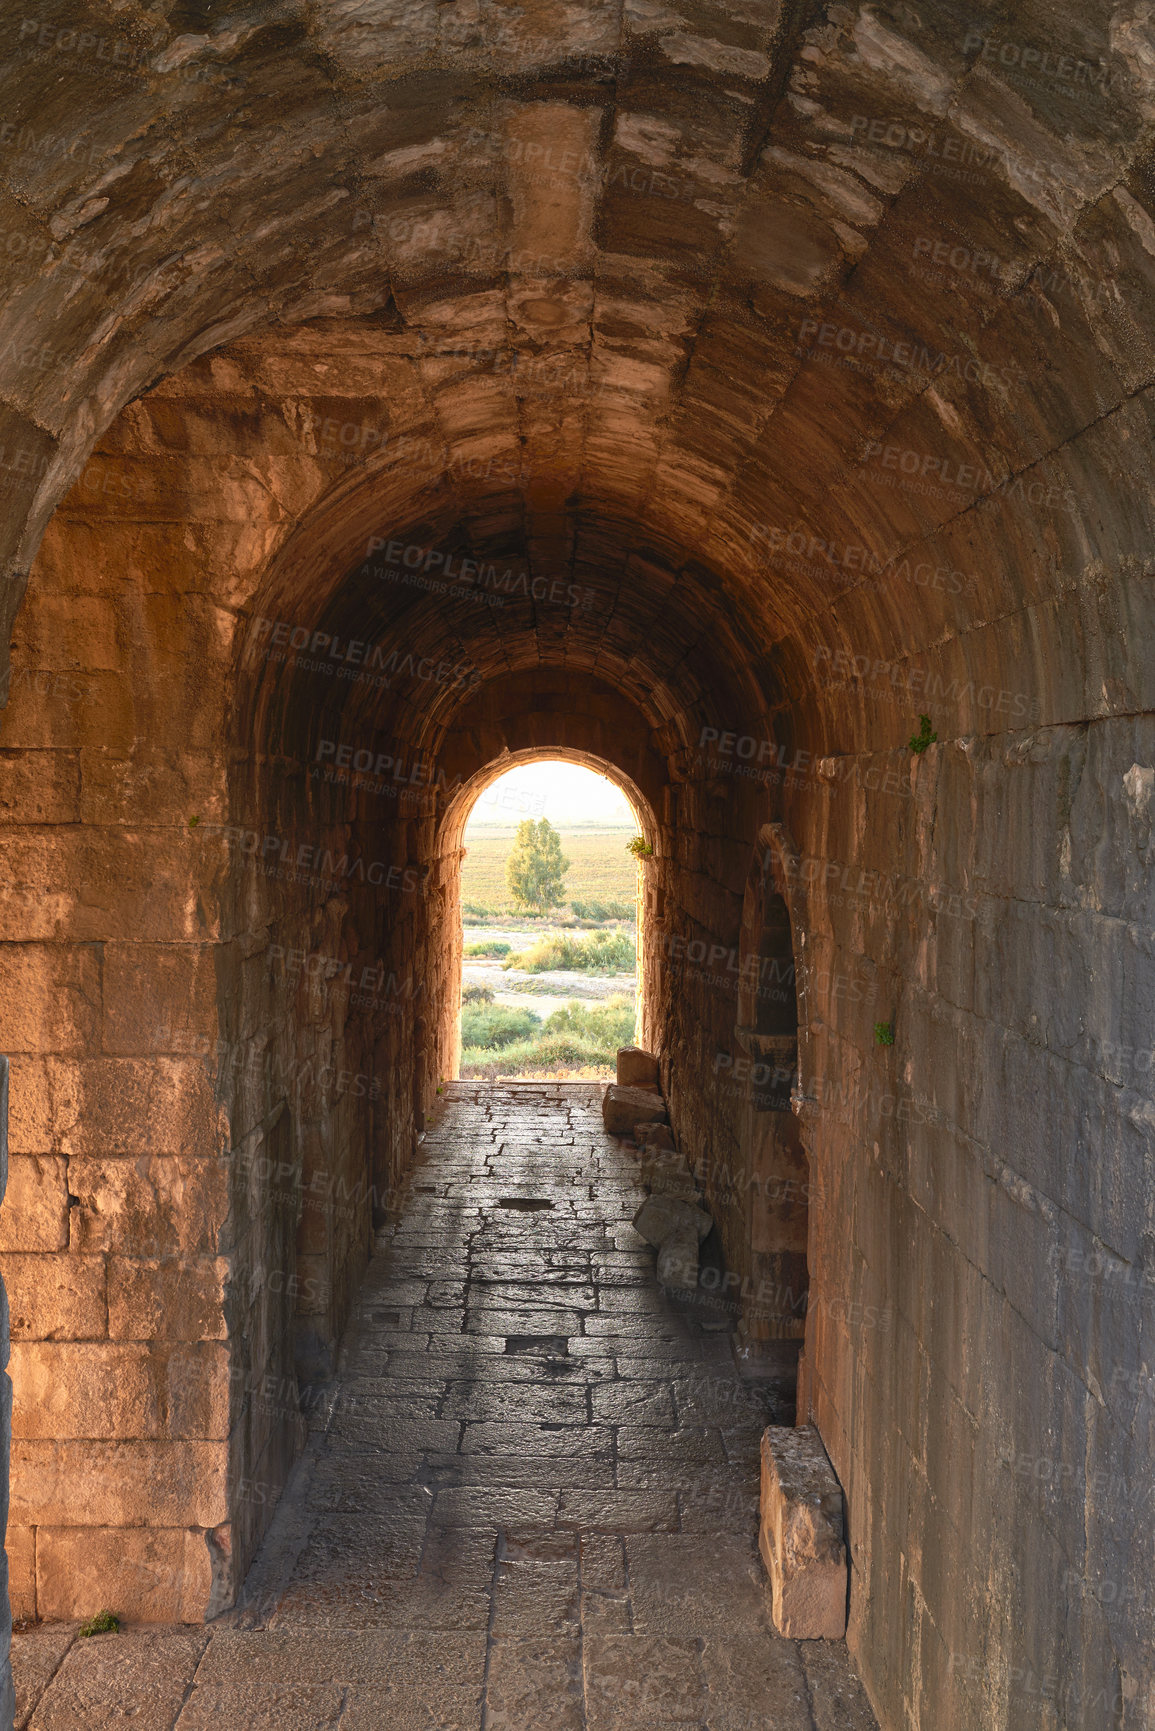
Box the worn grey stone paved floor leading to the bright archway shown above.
[14,1084,874,1731]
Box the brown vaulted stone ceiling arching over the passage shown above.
[9,0,1155,737]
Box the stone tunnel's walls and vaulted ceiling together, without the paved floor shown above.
[0,0,1155,1731]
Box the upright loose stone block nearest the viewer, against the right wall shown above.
[758,1425,849,1641]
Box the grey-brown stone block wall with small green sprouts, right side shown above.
[775,720,1155,1731]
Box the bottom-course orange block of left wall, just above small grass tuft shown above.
[36,1527,211,1622]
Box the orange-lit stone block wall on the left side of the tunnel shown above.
[0,409,447,1620]
